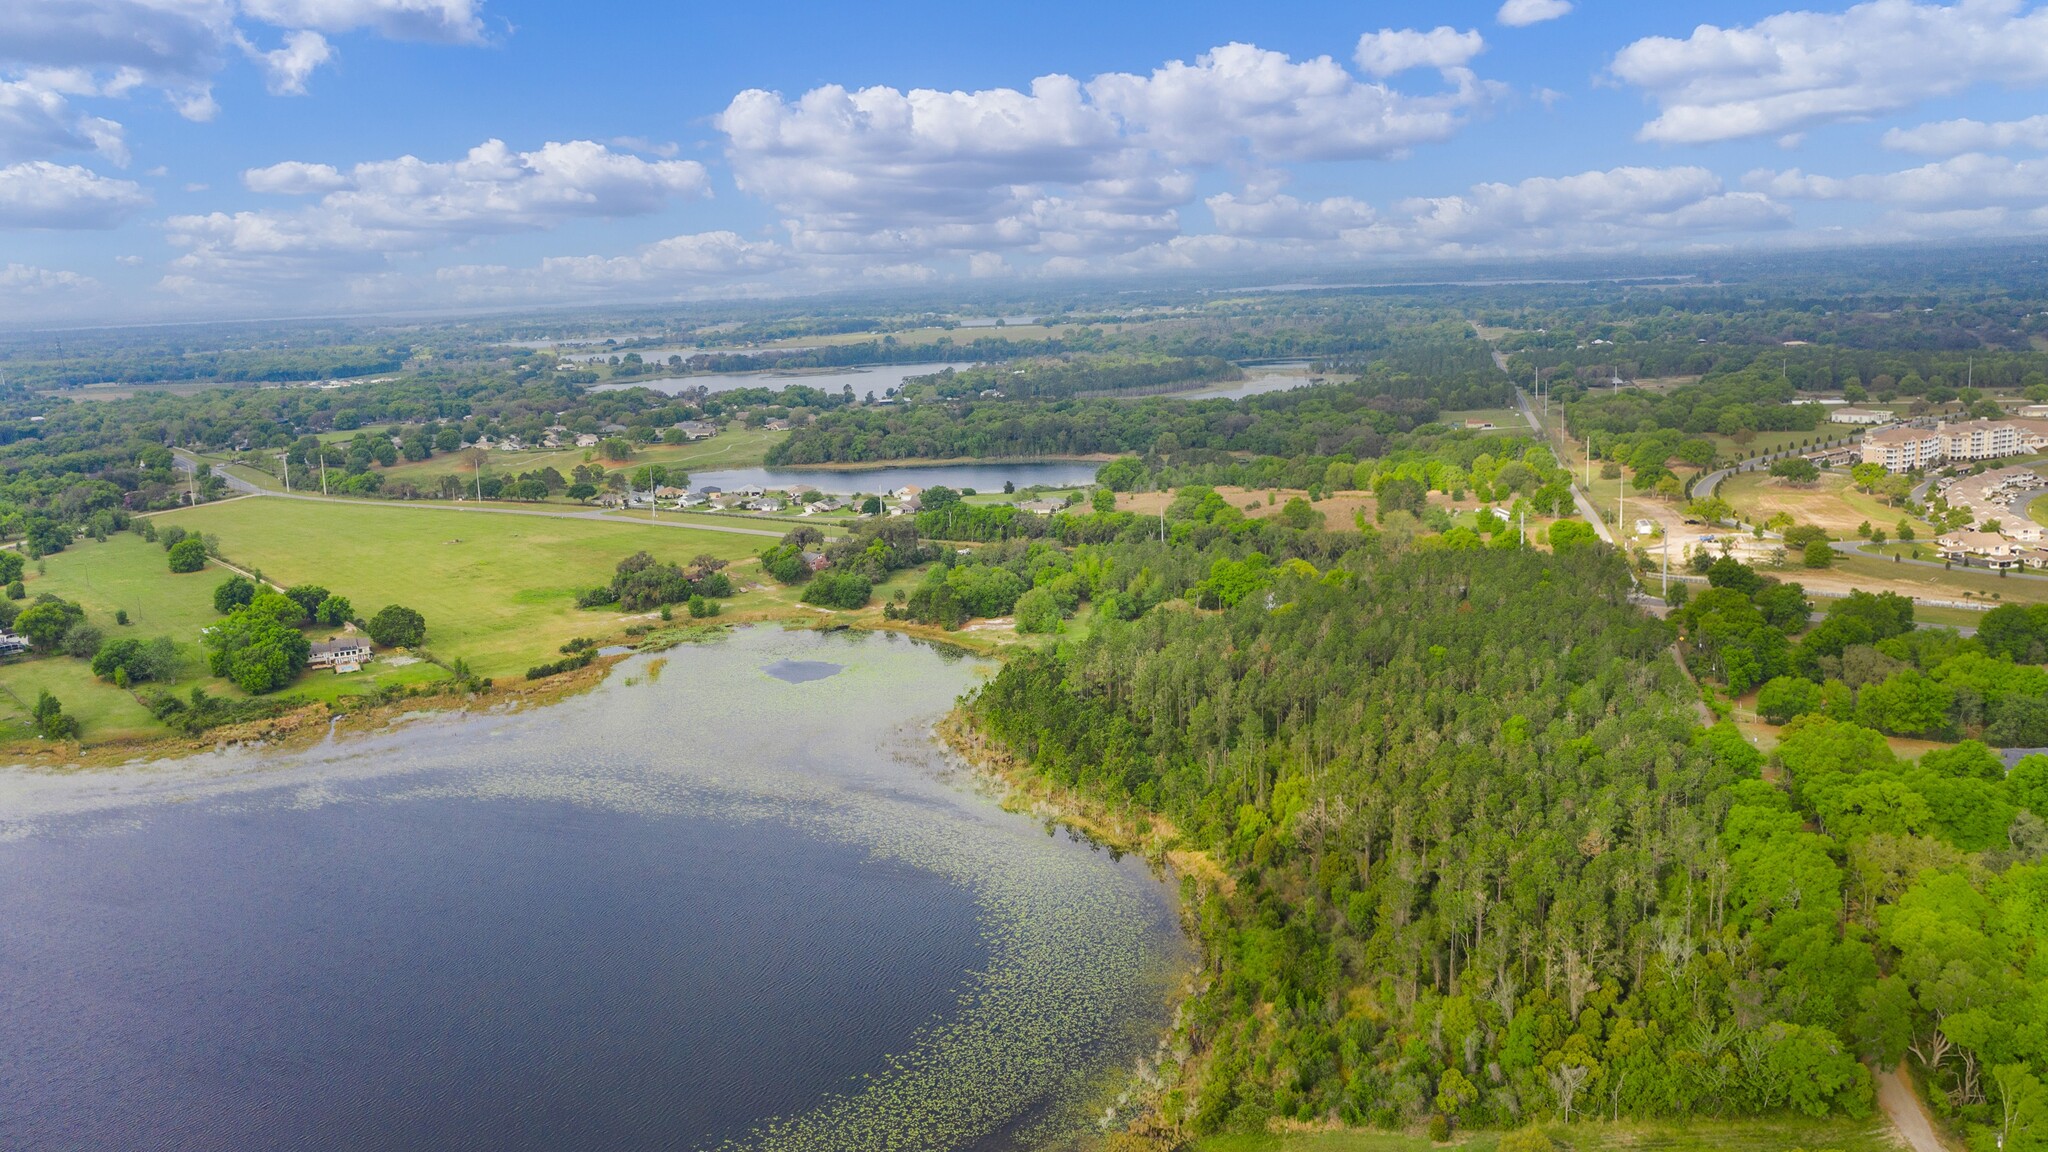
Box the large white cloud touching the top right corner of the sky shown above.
[1612,0,2048,143]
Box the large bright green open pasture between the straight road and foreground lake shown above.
[158,498,770,676]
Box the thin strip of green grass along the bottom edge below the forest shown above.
[1194,1117,1898,1152]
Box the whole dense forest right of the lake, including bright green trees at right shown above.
[967,537,2048,1146]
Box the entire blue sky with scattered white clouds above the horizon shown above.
[0,0,2048,322]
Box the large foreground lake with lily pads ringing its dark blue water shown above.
[0,629,1186,1152]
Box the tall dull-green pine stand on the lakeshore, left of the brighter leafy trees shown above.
[969,537,1908,1132]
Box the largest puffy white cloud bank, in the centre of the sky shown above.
[715,38,1499,256]
